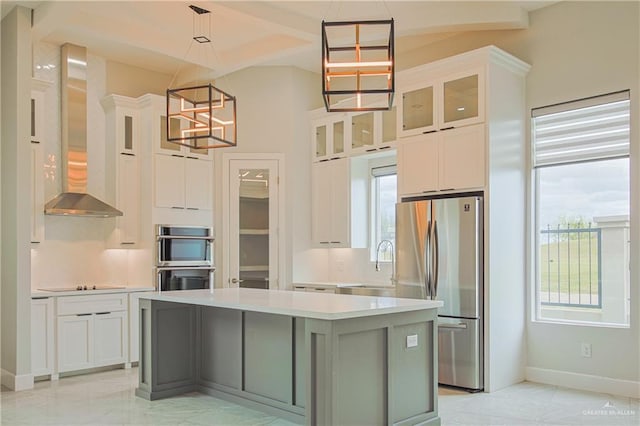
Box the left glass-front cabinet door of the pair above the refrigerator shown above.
[398,85,437,136]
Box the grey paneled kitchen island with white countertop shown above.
[136,289,442,425]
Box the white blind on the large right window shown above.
[531,90,630,167]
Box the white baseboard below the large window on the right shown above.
[525,367,640,398]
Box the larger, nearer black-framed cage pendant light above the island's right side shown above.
[322,19,395,112]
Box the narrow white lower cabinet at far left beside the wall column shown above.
[31,297,55,376]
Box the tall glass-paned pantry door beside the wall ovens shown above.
[228,160,278,289]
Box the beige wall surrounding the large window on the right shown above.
[527,2,640,397]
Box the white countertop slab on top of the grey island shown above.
[141,288,443,320]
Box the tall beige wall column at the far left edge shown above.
[0,7,33,390]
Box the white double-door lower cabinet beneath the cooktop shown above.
[56,293,129,373]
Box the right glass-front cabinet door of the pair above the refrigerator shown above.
[439,70,484,129]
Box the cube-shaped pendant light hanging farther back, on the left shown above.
[167,5,237,149]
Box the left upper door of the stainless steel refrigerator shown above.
[396,200,431,299]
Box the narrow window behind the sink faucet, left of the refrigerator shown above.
[370,165,397,262]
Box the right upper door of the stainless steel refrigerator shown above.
[431,197,482,318]
